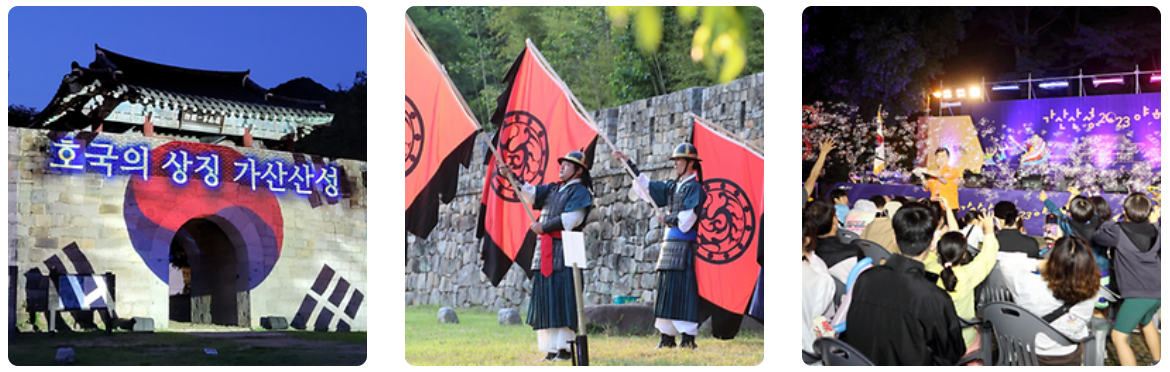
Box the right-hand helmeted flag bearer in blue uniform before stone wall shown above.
[614,143,704,349]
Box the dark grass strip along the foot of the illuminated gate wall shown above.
[8,331,366,366]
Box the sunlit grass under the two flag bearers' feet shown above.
[406,306,764,366]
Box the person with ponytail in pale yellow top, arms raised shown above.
[923,218,999,365]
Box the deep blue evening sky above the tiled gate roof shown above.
[8,7,367,110]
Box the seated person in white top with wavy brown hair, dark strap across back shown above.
[999,235,1100,365]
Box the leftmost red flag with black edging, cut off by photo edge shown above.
[405,16,480,239]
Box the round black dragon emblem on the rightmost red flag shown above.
[696,178,756,264]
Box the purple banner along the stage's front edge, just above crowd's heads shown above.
[833,184,1126,236]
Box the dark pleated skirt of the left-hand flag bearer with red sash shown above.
[528,268,577,331]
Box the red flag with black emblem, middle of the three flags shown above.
[476,41,597,285]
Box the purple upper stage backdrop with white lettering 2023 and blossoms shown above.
[971,92,1162,170]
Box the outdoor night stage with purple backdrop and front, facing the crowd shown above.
[823,87,1162,235]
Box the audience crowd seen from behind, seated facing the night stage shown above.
[801,142,1161,365]
